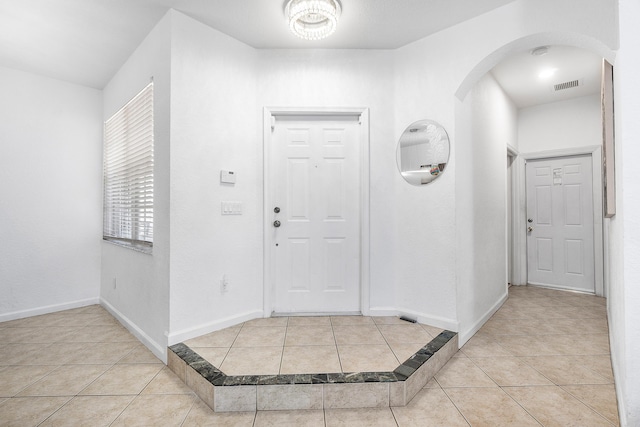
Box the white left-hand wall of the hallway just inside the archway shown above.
[456,74,518,342]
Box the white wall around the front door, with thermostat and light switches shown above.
[169,13,399,342]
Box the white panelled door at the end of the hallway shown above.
[526,156,595,292]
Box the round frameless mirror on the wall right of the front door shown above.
[396,120,449,185]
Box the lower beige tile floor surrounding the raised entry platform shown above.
[0,287,618,427]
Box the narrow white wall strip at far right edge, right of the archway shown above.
[607,0,640,426]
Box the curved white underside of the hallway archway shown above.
[455,32,616,101]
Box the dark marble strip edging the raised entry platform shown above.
[169,331,456,386]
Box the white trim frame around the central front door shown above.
[262,107,370,317]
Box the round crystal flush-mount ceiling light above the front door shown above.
[284,0,342,40]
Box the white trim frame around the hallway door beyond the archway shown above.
[514,145,606,296]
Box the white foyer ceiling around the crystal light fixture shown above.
[0,0,513,89]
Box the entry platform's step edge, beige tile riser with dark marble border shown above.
[168,331,458,411]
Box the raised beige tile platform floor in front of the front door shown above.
[180,316,442,375]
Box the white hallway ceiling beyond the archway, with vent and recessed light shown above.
[491,46,602,108]
